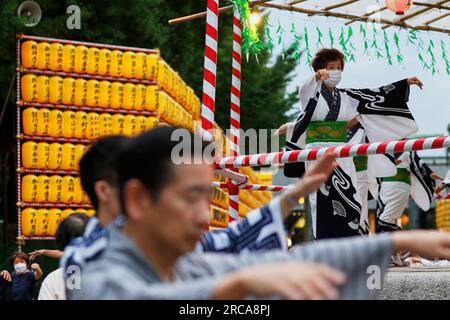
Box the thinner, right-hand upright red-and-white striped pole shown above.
[228,8,241,222]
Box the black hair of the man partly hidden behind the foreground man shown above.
[80,136,129,209]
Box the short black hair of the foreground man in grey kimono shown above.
[118,126,214,215]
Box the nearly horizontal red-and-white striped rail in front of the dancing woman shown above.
[216,136,450,168]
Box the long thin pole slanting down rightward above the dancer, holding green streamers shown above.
[258,3,450,35]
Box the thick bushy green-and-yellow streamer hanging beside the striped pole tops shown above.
[231,0,264,60]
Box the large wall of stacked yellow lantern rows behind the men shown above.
[18,40,206,237]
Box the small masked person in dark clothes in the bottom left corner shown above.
[0,252,42,300]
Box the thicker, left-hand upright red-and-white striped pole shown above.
[201,0,219,141]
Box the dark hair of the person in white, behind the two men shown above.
[55,213,89,251]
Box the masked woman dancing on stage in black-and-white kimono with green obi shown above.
[278,48,423,239]
